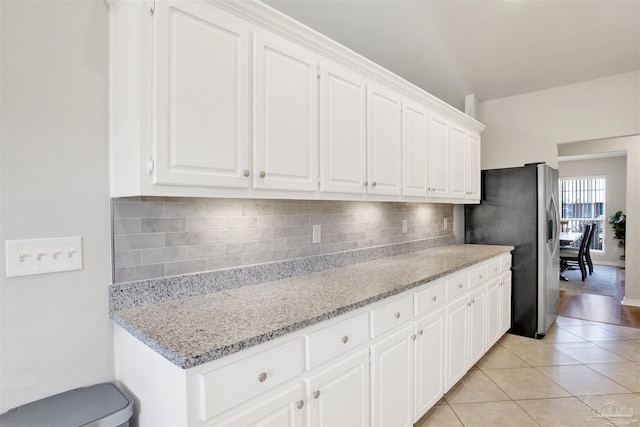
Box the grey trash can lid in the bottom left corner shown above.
[0,383,133,427]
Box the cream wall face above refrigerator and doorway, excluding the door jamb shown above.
[477,71,640,169]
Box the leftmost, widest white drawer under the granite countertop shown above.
[198,339,303,421]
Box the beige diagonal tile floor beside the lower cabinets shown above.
[414,317,640,427]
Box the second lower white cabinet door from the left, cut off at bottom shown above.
[307,347,369,427]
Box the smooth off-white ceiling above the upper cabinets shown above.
[263,0,640,110]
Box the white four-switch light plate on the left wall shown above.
[5,236,82,277]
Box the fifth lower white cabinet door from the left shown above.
[444,295,469,393]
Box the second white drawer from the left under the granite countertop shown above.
[306,312,369,369]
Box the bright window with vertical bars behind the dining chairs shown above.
[560,177,606,251]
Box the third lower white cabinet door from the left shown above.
[371,323,414,427]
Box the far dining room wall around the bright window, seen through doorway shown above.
[558,156,627,265]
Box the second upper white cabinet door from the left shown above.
[253,33,318,191]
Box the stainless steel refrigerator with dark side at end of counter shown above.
[465,163,560,338]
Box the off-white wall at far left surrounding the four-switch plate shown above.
[0,0,114,412]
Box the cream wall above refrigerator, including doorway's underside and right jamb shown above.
[479,71,640,305]
